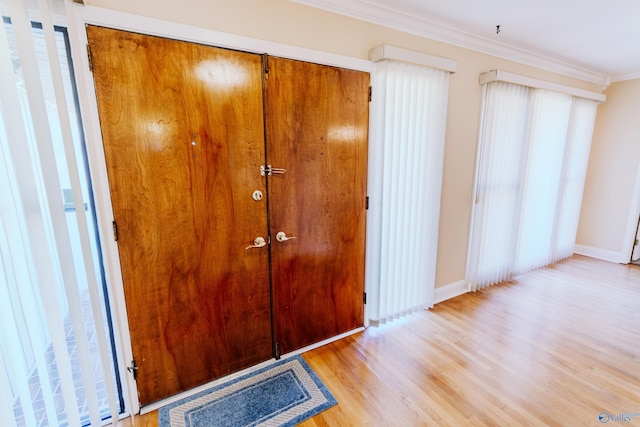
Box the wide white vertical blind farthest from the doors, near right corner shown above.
[467,81,597,290]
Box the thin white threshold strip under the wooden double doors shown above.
[139,327,365,415]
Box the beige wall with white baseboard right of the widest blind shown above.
[576,79,640,263]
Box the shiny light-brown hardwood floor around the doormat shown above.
[112,256,640,427]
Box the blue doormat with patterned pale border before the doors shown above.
[158,356,338,427]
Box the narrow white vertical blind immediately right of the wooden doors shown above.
[367,60,450,321]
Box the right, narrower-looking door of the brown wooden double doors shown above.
[265,57,369,353]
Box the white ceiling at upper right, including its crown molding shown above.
[292,0,640,87]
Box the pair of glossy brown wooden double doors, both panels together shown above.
[87,26,369,405]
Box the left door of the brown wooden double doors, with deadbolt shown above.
[87,26,272,405]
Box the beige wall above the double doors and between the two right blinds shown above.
[82,0,595,287]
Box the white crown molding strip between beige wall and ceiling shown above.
[289,0,608,85]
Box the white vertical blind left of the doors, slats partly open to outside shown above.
[0,0,122,426]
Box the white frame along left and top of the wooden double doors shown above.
[65,2,374,414]
